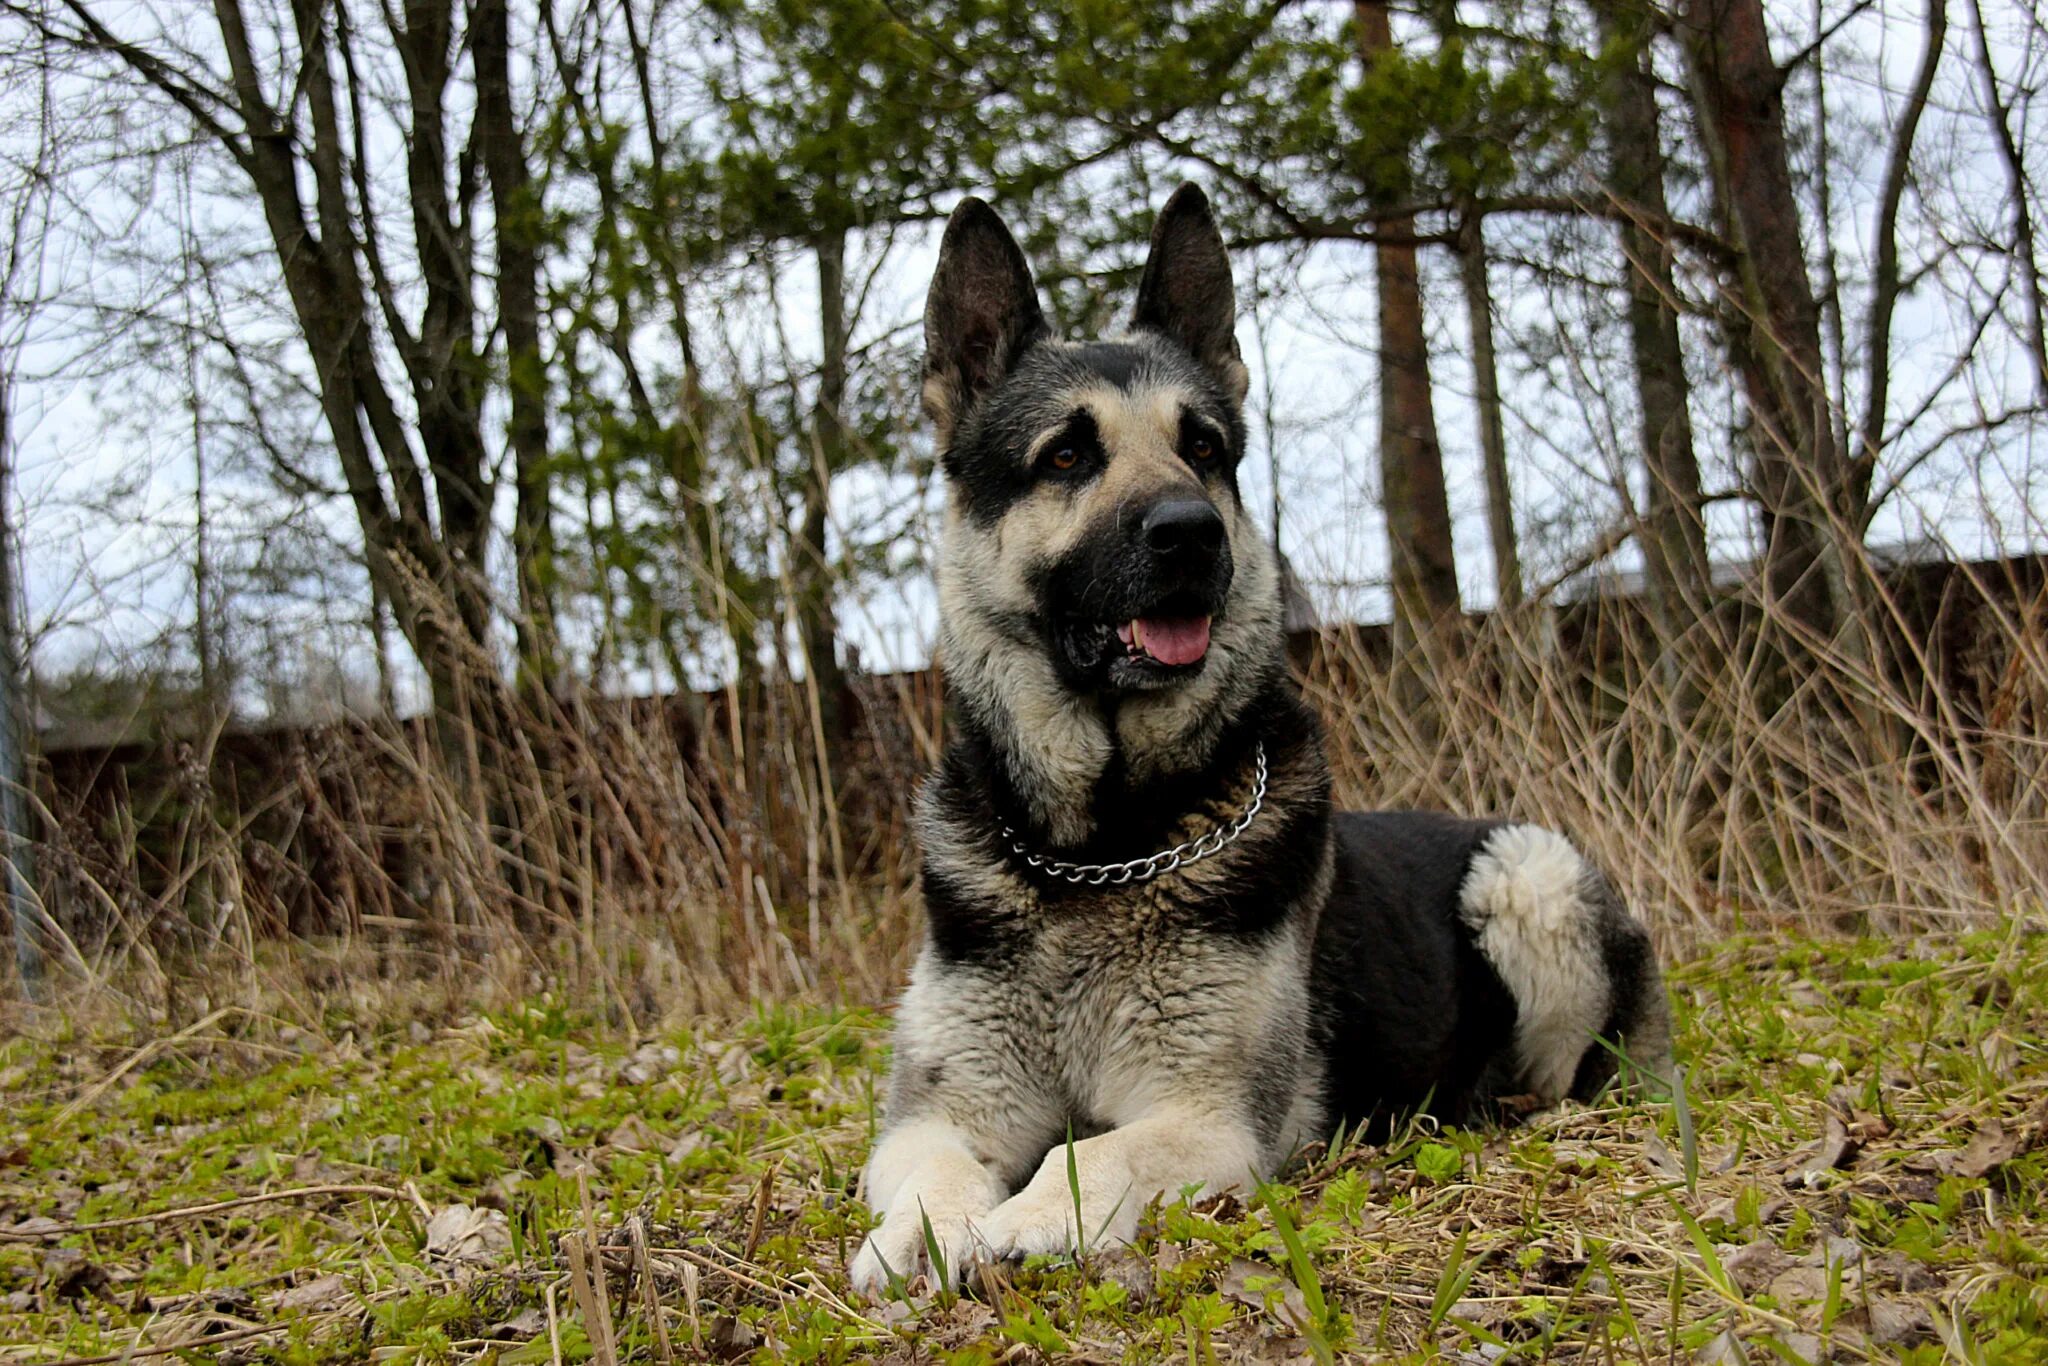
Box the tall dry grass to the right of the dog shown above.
[1307,544,2048,942]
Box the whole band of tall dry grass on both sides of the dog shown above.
[4,544,2048,1024]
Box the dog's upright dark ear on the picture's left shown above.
[924,199,1047,446]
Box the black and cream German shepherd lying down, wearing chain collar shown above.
[852,184,1669,1294]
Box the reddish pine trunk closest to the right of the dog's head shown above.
[1354,0,1460,657]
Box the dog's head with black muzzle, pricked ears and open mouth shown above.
[924,184,1278,739]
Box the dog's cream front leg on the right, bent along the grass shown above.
[979,1108,1264,1257]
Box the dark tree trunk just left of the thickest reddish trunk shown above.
[1595,0,1712,641]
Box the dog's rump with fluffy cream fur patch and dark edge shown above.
[1458,825,1671,1104]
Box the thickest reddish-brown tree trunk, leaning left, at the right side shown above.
[1679,0,1862,641]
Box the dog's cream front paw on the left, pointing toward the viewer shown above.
[850,1118,1004,1298]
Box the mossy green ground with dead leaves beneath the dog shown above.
[0,926,2048,1364]
